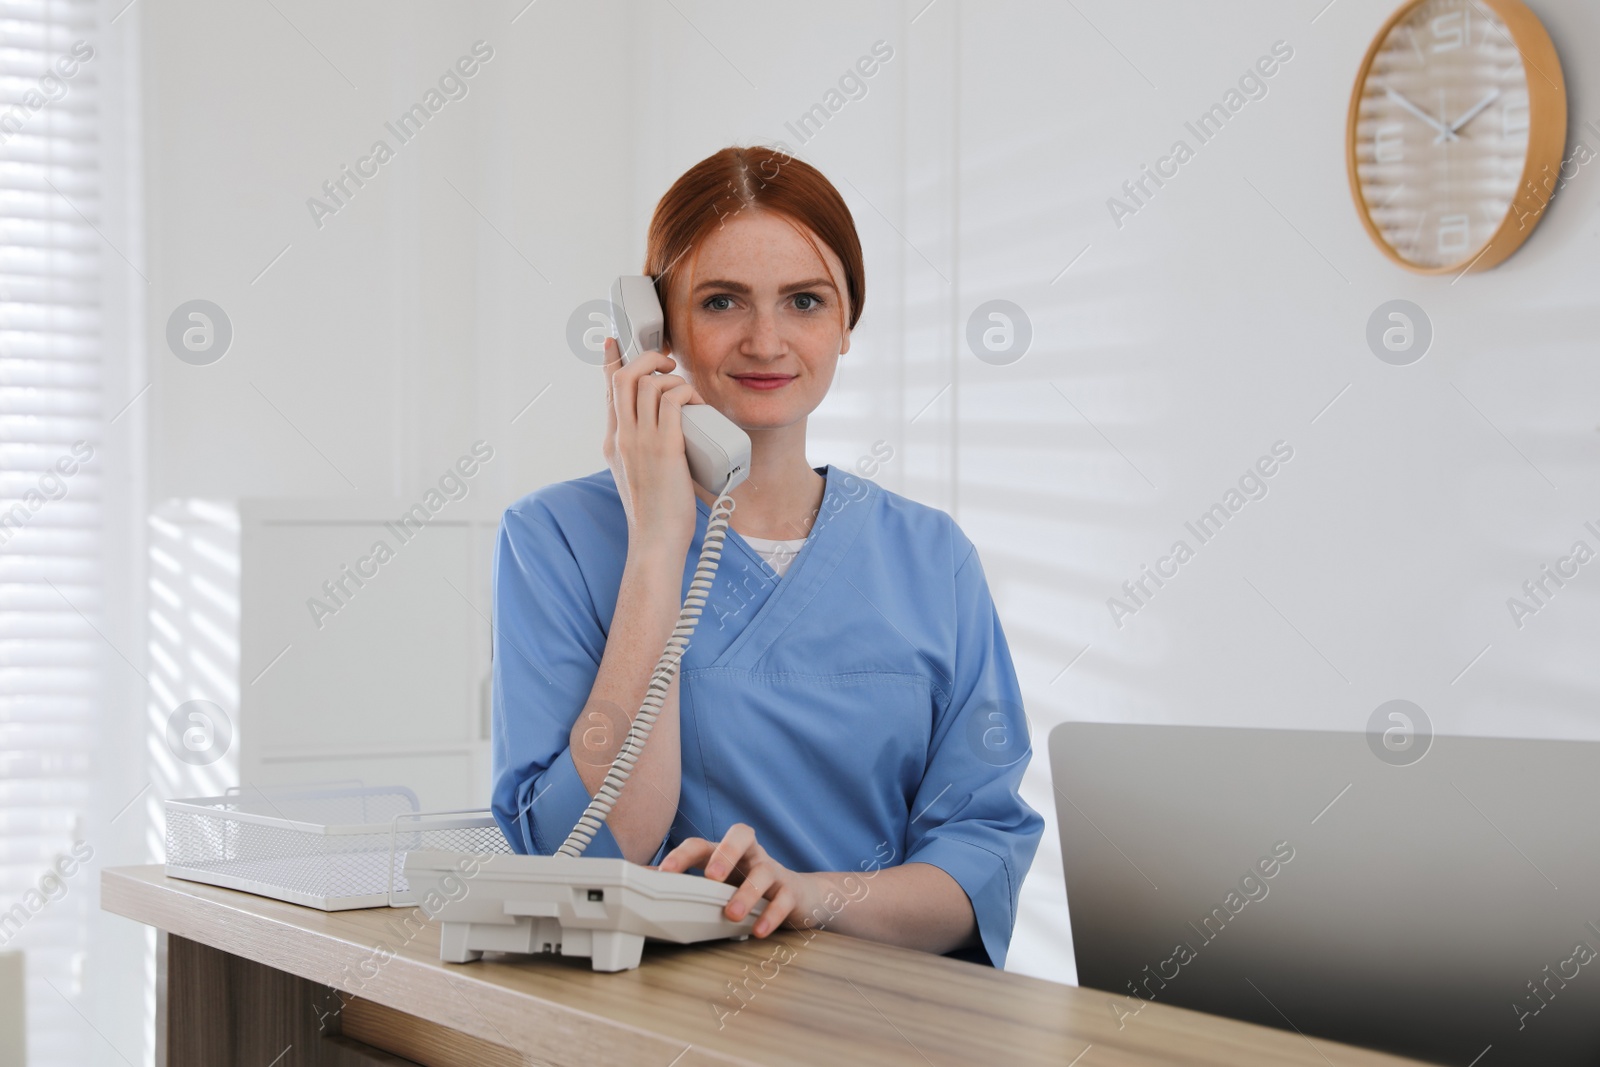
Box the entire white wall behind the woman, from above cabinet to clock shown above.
[128,0,1600,1017]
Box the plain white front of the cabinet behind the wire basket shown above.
[238,499,499,809]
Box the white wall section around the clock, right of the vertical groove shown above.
[934,0,1600,976]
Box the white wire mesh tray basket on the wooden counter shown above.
[166,785,512,912]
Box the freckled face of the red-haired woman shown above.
[669,210,850,430]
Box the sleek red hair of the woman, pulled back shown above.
[645,146,867,351]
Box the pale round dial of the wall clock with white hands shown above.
[1350,0,1529,269]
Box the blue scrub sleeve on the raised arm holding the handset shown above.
[491,502,659,861]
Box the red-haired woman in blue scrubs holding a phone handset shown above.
[493,147,1043,966]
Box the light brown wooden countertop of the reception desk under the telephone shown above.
[101,865,1440,1067]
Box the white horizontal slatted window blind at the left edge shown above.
[0,0,101,1067]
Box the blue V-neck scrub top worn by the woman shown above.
[493,466,1045,966]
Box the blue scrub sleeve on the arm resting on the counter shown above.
[906,550,1045,968]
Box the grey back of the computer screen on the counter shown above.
[1050,720,1600,1067]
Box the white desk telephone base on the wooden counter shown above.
[405,851,766,971]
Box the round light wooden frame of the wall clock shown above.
[1344,0,1566,274]
